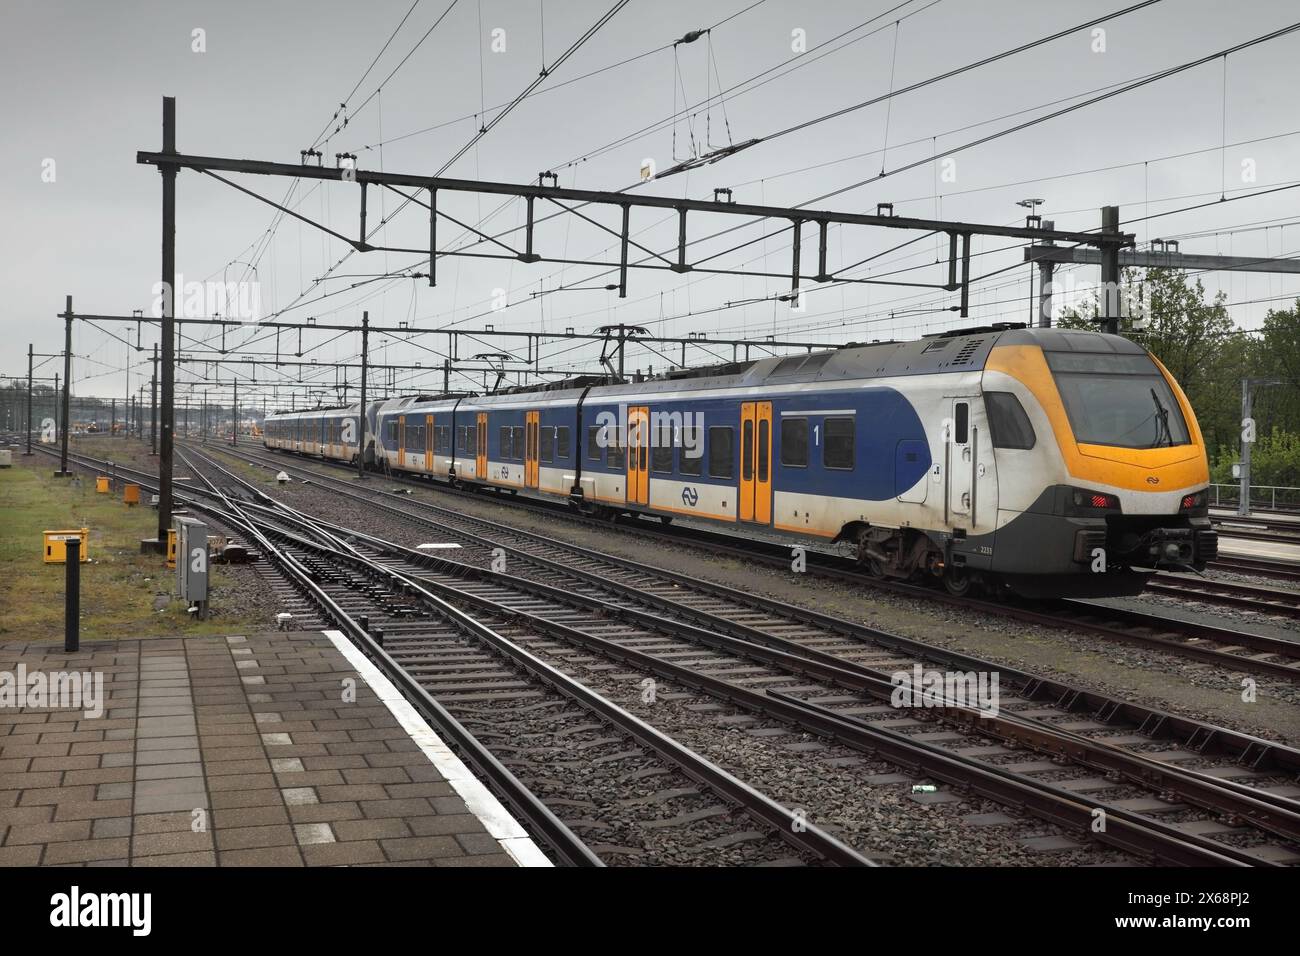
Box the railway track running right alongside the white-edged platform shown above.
[45,450,872,865]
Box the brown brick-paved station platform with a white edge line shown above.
[0,631,549,866]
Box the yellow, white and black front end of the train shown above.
[983,329,1218,597]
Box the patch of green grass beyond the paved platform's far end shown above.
[0,455,255,640]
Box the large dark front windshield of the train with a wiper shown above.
[1045,352,1191,449]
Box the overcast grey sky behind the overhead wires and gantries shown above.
[0,0,1300,405]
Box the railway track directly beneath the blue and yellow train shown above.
[213,450,1300,680]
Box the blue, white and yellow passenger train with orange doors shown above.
[264,324,1218,598]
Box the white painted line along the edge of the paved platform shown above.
[321,631,555,866]
